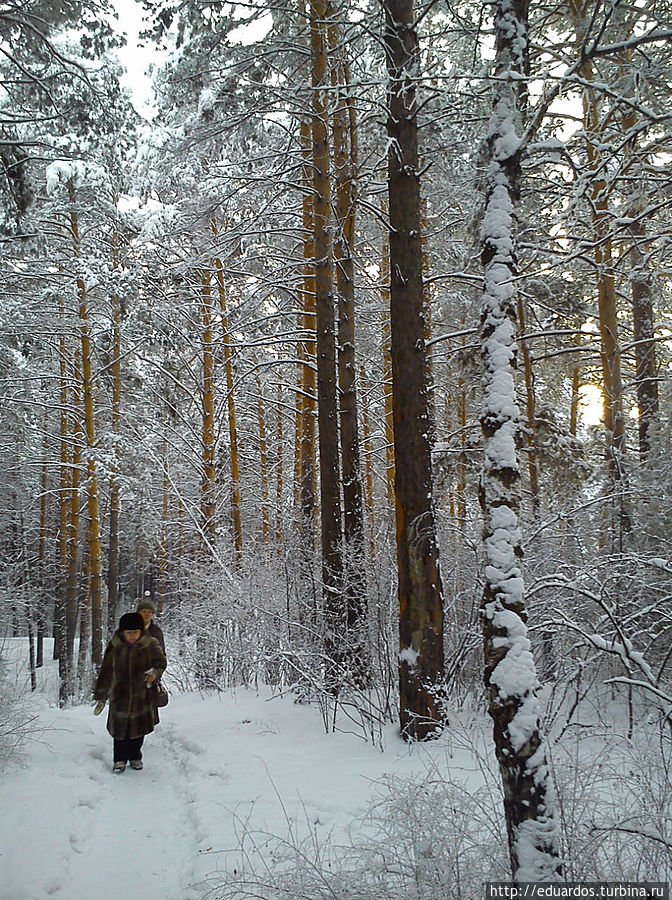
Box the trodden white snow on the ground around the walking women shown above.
[0,640,488,900]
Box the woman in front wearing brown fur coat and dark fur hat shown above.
[93,613,166,772]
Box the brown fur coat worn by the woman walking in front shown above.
[93,631,166,740]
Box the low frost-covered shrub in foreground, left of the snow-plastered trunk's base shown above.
[206,772,508,900]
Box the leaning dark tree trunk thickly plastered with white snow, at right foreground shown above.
[480,0,560,881]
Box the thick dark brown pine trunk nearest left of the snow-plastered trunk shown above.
[384,0,444,740]
